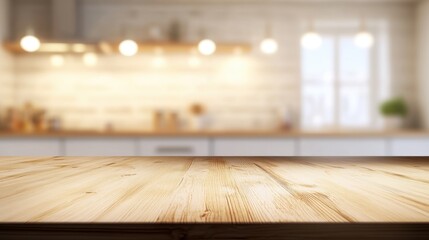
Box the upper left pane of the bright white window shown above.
[301,37,335,82]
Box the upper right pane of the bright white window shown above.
[339,36,370,82]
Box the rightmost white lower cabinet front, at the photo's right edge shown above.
[390,137,429,156]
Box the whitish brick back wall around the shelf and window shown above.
[10,0,416,129]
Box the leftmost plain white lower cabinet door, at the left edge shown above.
[0,138,62,156]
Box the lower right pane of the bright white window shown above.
[339,85,371,127]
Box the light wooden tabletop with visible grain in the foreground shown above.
[0,157,429,223]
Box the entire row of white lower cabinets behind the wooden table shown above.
[0,137,429,156]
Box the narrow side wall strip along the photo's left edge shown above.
[0,0,14,108]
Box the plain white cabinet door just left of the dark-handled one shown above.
[64,138,137,156]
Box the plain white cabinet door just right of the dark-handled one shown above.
[213,138,296,156]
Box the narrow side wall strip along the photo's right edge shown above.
[417,0,429,129]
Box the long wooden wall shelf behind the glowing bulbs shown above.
[3,42,252,54]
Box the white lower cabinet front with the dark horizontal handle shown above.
[138,137,210,156]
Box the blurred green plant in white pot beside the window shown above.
[380,97,408,130]
